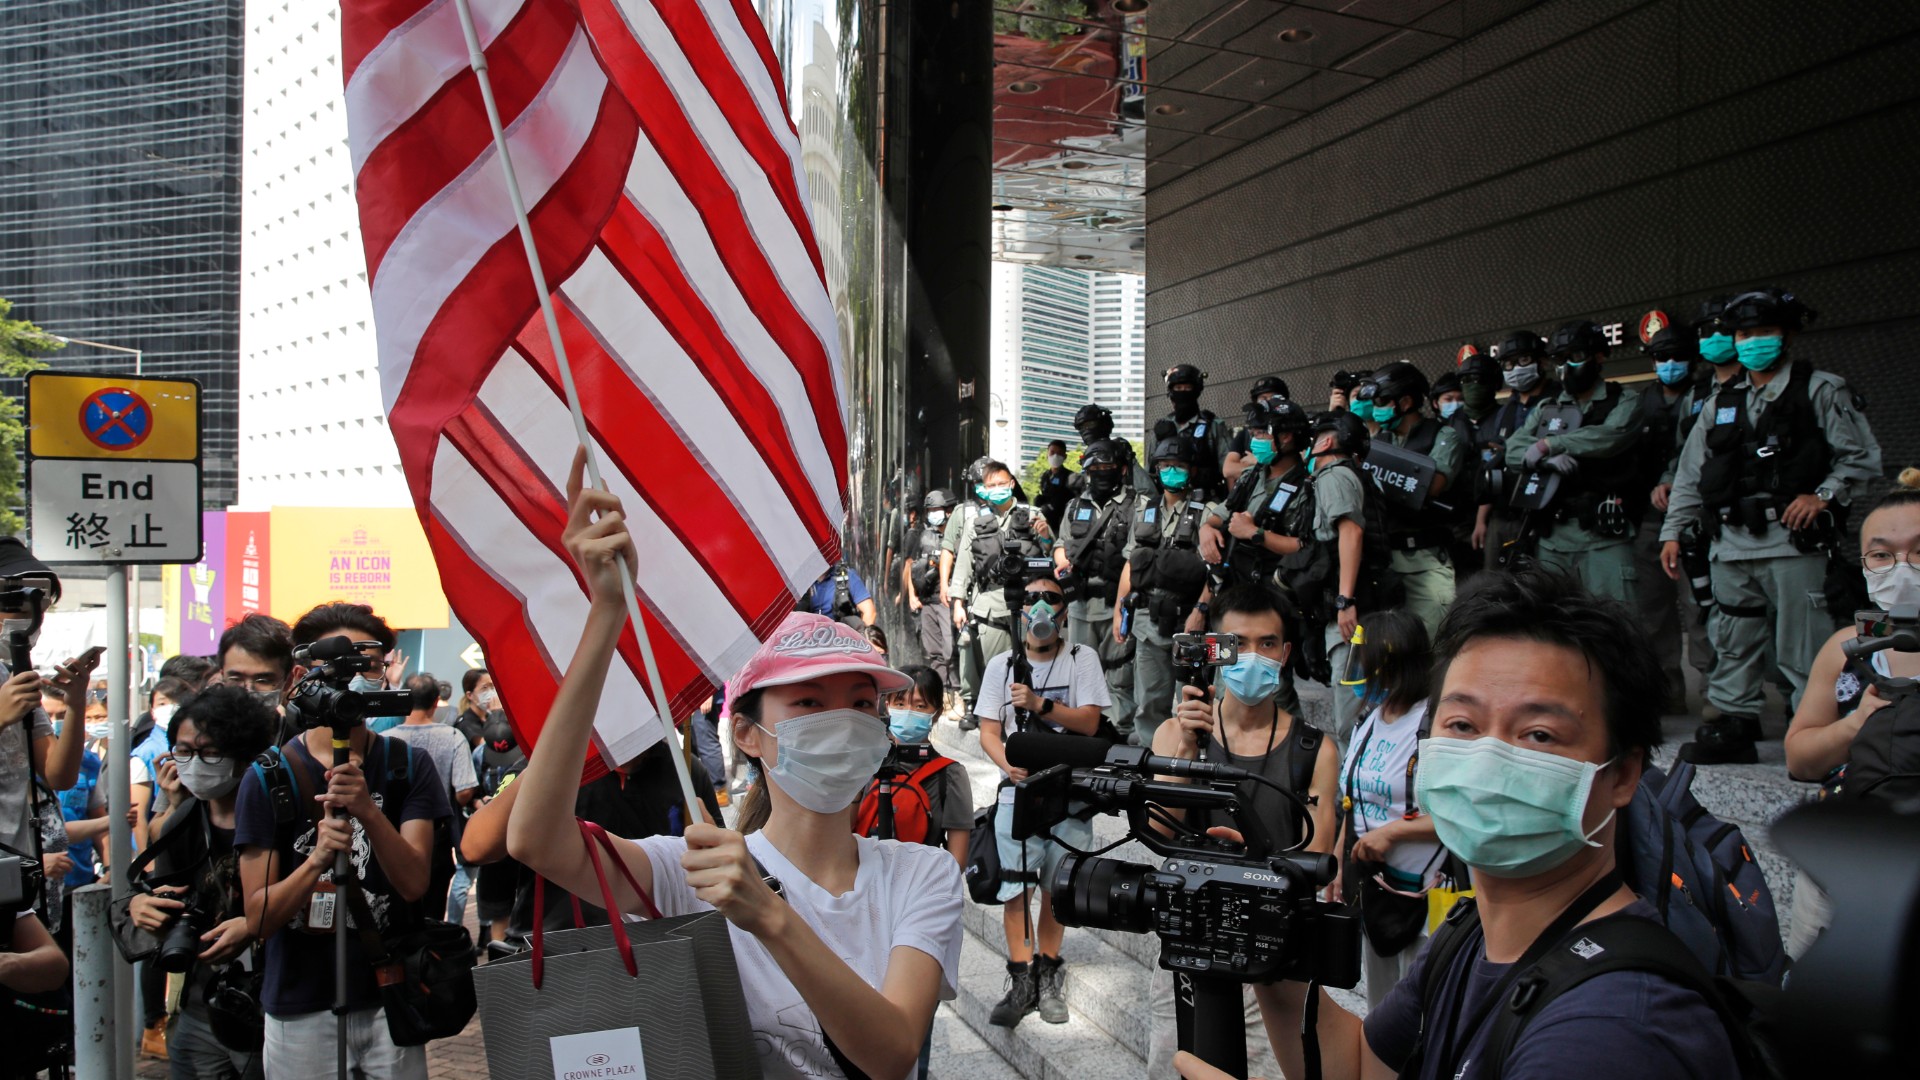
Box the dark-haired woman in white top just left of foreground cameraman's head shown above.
[1331,611,1446,1009]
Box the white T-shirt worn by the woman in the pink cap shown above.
[636,832,962,1080]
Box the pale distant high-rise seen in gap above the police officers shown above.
[989,263,1146,471]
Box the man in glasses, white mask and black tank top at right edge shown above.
[1786,469,1920,957]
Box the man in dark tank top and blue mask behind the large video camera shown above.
[1146,584,1340,1078]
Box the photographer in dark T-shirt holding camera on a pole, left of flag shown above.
[236,603,451,1080]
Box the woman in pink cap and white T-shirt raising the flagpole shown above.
[507,447,962,1080]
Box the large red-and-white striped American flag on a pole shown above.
[342,0,847,774]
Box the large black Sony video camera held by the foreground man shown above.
[1006,732,1359,988]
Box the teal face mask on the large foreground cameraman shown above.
[1413,738,1613,878]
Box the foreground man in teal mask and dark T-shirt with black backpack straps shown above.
[1179,571,1738,1080]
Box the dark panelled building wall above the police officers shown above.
[1146,0,1920,471]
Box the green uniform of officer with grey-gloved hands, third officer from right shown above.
[1507,382,1644,603]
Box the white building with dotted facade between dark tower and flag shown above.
[240,0,409,507]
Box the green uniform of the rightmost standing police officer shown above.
[1661,357,1880,717]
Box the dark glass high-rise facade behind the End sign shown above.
[0,0,242,507]
